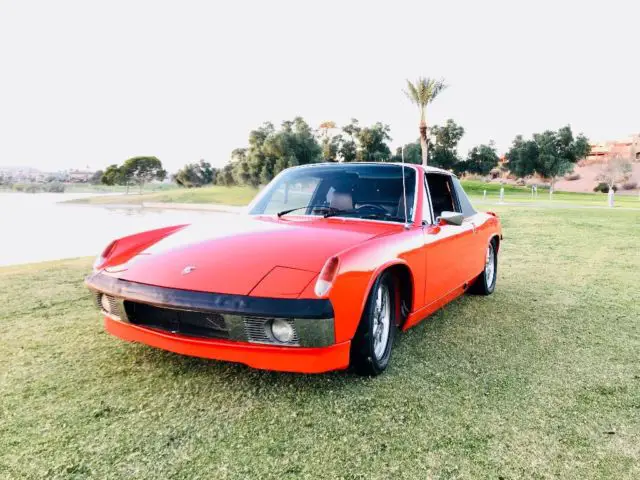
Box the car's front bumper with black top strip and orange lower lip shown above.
[85,272,350,373]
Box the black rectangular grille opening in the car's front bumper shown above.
[124,300,229,338]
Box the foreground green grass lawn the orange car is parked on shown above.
[0,206,640,479]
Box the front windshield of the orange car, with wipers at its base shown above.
[249,163,416,222]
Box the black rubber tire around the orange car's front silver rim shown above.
[351,272,398,377]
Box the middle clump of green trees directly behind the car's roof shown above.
[173,117,520,187]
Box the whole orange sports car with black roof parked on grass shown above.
[86,163,502,375]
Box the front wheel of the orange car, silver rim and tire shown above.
[351,273,397,376]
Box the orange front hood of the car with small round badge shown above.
[112,215,402,296]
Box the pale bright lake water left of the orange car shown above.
[0,193,234,265]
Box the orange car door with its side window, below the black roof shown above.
[423,172,475,305]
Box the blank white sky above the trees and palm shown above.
[0,0,640,171]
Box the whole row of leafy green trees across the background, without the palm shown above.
[87,117,589,190]
